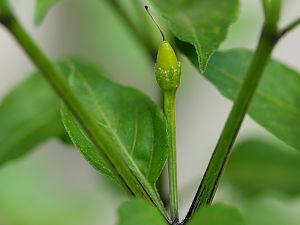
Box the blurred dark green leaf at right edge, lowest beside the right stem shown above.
[224,139,300,195]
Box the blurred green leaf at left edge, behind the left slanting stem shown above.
[0,74,65,164]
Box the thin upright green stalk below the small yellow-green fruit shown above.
[164,90,179,223]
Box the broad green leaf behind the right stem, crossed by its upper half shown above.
[184,48,300,150]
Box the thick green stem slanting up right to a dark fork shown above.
[184,3,280,223]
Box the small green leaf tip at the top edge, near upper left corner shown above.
[34,0,60,26]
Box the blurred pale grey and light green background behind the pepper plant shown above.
[0,0,300,225]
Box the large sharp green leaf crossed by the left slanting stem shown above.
[62,61,168,184]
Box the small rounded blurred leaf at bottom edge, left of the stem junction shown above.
[117,199,168,225]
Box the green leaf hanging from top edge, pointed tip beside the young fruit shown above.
[151,0,239,72]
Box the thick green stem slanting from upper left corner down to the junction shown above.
[0,3,167,221]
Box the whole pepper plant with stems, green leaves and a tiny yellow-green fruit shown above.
[0,0,300,225]
